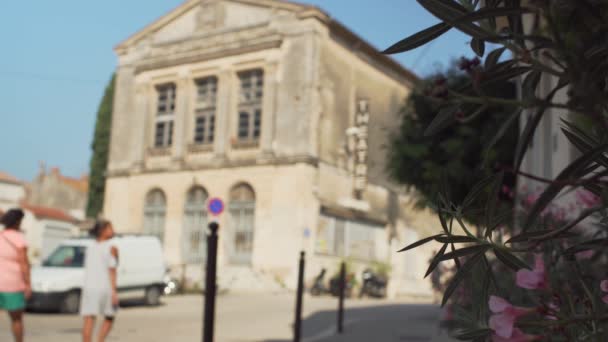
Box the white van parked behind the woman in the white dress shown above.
[28,235,166,313]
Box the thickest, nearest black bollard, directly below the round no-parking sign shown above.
[203,222,220,342]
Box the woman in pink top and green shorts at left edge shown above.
[0,209,32,342]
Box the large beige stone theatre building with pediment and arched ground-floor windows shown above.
[104,0,438,296]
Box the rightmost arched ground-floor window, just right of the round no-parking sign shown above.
[228,184,255,265]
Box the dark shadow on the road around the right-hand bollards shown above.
[263,304,439,342]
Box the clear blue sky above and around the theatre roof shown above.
[0,0,471,180]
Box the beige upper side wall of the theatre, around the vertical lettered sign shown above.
[319,29,412,185]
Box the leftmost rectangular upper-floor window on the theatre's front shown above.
[154,83,176,148]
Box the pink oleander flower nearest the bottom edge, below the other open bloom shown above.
[488,296,533,341]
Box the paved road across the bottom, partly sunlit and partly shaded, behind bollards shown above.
[0,293,446,342]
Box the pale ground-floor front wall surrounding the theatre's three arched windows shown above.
[104,164,318,269]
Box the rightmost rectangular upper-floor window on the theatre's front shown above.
[238,69,264,143]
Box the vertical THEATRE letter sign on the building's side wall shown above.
[354,100,369,198]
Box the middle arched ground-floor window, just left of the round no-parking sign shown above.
[182,186,209,263]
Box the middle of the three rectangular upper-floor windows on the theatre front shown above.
[194,77,217,145]
